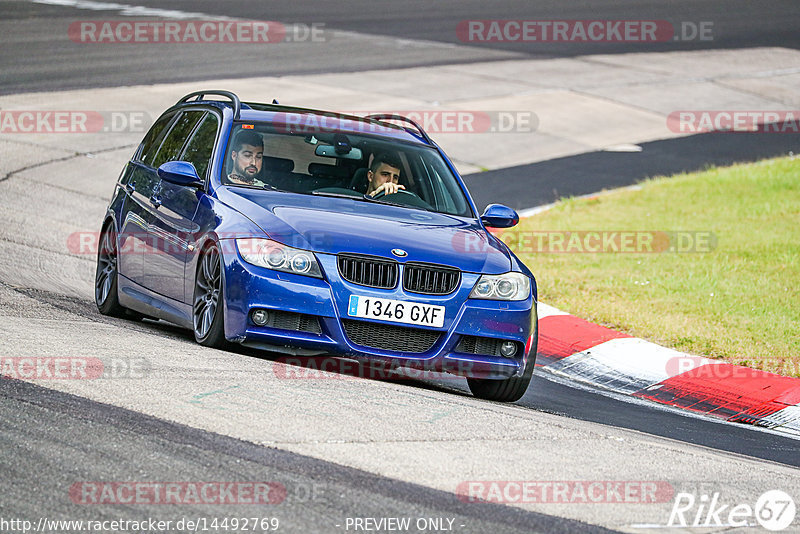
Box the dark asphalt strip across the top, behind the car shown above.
[0,0,800,94]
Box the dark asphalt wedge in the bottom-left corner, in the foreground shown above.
[0,380,612,534]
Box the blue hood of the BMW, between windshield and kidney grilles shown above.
[218,187,511,274]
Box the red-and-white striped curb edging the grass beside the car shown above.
[536,304,800,436]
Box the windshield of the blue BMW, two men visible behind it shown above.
[221,122,474,217]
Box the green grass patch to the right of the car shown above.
[501,158,800,376]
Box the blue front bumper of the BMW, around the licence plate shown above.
[217,248,536,379]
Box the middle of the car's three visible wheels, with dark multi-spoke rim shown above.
[192,245,227,349]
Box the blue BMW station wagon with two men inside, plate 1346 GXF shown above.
[95,91,537,402]
